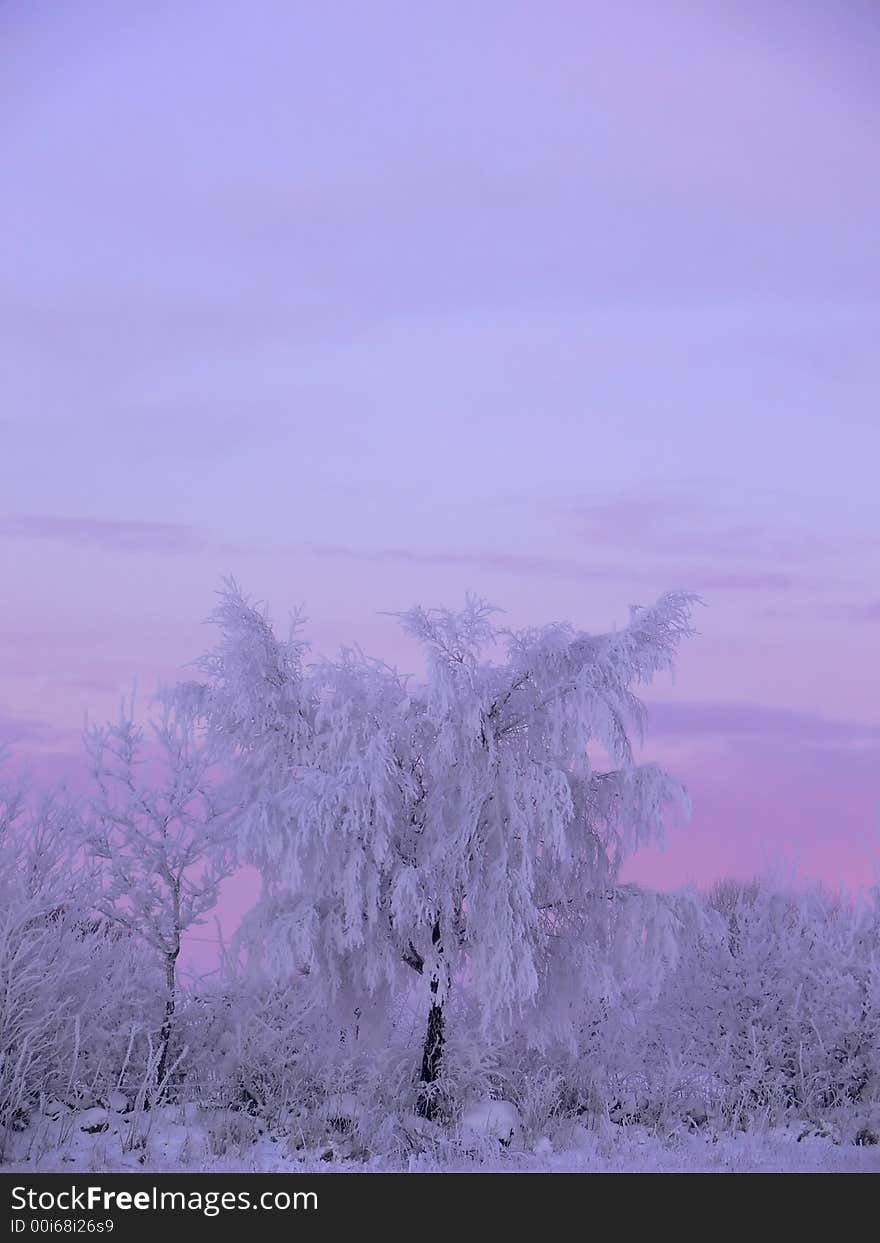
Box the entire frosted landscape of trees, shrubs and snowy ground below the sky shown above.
[0,583,880,1171]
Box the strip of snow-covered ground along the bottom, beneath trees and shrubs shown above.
[0,1106,880,1173]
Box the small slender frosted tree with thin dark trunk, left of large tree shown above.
[86,697,232,1090]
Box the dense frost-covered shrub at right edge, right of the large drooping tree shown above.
[629,885,880,1125]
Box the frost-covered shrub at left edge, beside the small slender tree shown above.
[0,793,175,1146]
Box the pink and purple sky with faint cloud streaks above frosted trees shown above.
[0,0,880,924]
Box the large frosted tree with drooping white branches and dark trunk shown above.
[186,583,695,1116]
